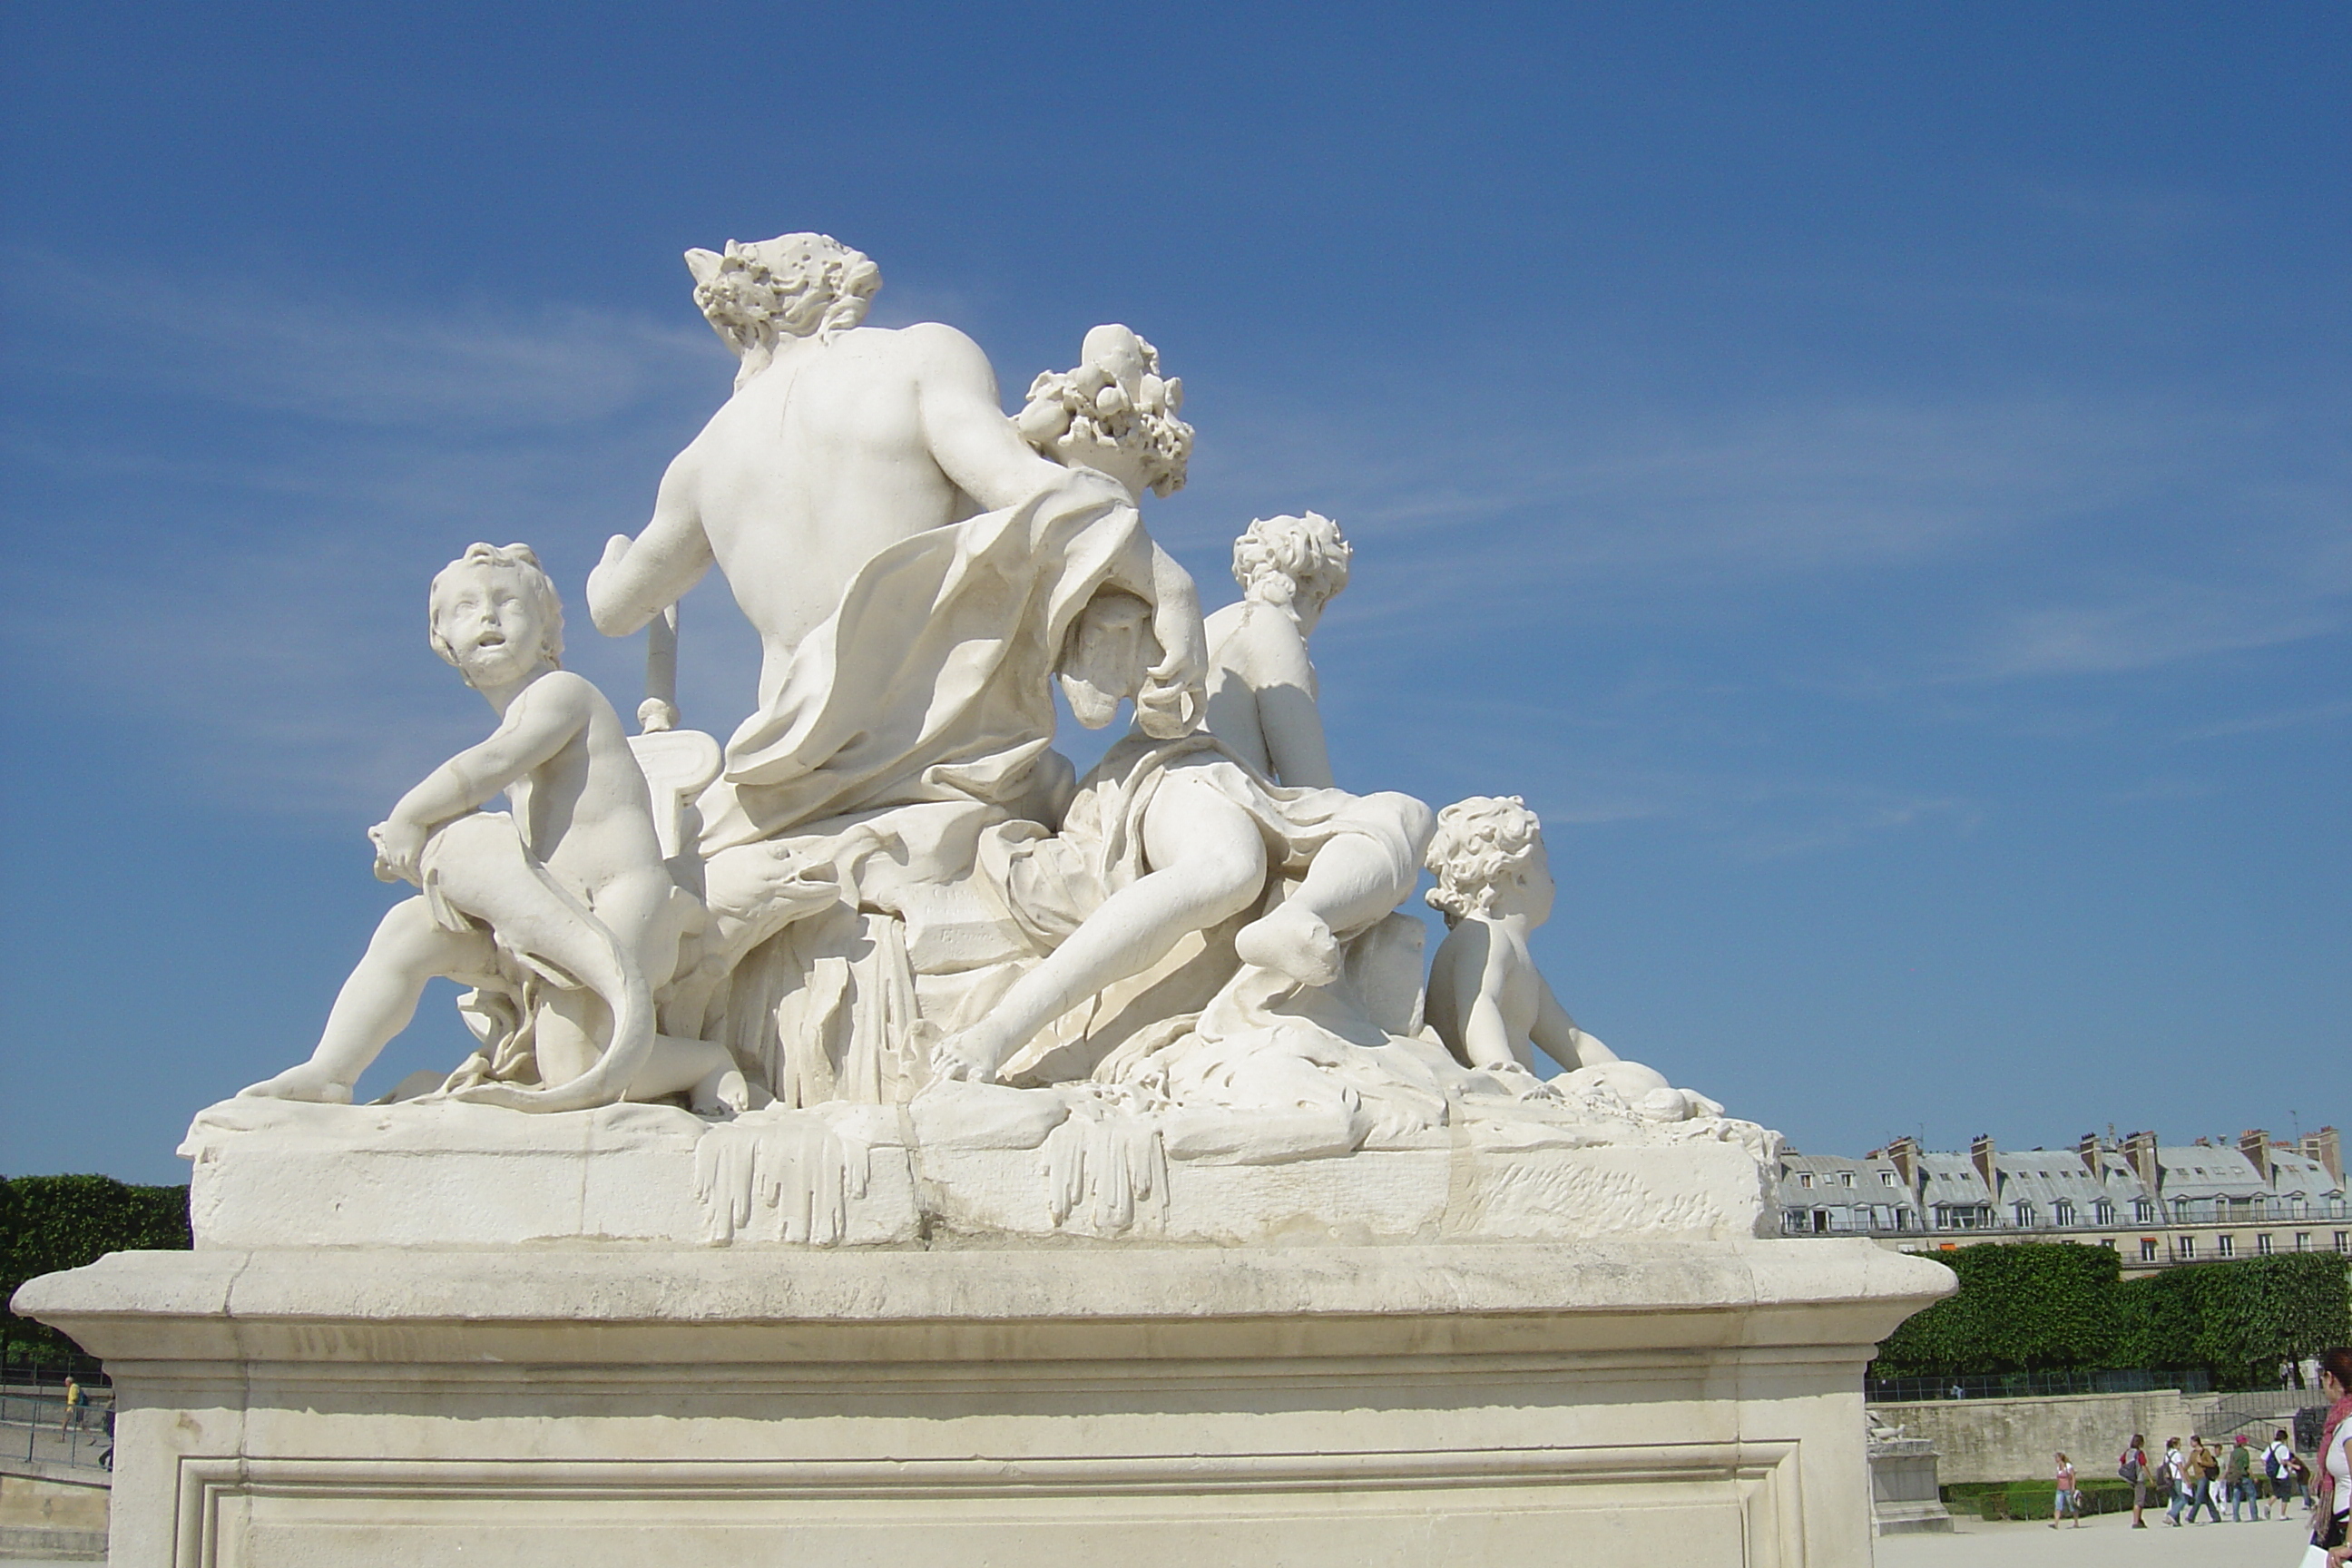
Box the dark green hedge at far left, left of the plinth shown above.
[0,1175,195,1361]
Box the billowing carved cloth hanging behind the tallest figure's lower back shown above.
[701,473,1143,856]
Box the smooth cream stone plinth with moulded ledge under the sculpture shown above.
[15,1239,1950,1568]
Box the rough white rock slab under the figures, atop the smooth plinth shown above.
[181,1091,1779,1246]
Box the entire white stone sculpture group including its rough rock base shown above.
[188,235,1771,1243]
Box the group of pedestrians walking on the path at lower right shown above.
[2116,1349,2352,1568]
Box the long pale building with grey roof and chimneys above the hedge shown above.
[1780,1126,2352,1274]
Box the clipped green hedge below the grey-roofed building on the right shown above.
[1870,1241,2352,1389]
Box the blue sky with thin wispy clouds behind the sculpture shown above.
[0,0,2352,1181]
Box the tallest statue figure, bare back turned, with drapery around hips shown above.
[588,235,1207,853]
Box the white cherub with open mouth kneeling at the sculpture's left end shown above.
[245,543,734,1110]
